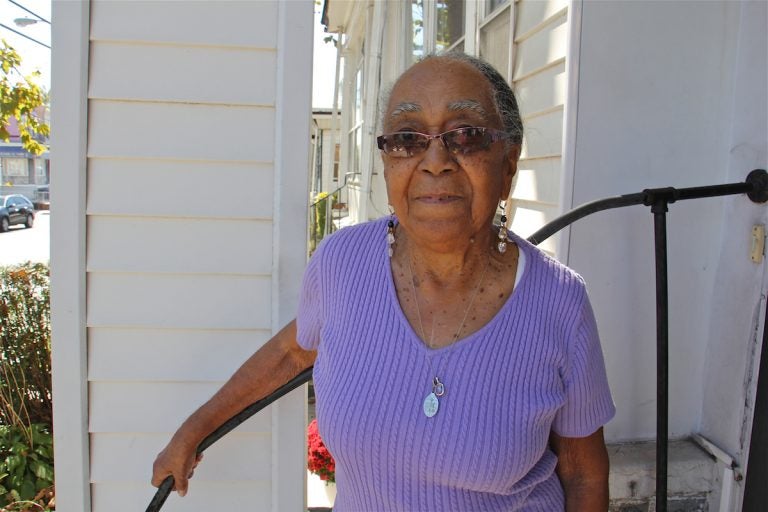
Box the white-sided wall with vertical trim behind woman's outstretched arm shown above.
[52,0,312,512]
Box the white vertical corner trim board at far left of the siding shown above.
[51,1,91,512]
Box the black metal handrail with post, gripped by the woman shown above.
[147,169,768,512]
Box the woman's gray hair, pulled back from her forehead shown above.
[381,51,523,144]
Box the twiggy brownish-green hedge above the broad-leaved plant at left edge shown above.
[0,263,53,432]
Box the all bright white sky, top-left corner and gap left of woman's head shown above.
[0,0,336,108]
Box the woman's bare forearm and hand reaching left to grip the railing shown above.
[152,320,317,496]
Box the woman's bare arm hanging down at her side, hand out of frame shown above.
[550,428,608,512]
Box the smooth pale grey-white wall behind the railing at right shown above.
[568,1,765,446]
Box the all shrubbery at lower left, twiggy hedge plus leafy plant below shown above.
[0,263,53,511]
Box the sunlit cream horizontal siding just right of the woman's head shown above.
[511,0,568,248]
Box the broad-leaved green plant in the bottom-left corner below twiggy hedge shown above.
[0,424,53,510]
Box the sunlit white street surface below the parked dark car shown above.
[0,210,51,267]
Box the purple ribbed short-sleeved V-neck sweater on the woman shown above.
[297,219,615,512]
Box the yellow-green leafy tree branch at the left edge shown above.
[0,39,50,155]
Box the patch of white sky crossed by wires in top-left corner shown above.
[0,0,51,90]
